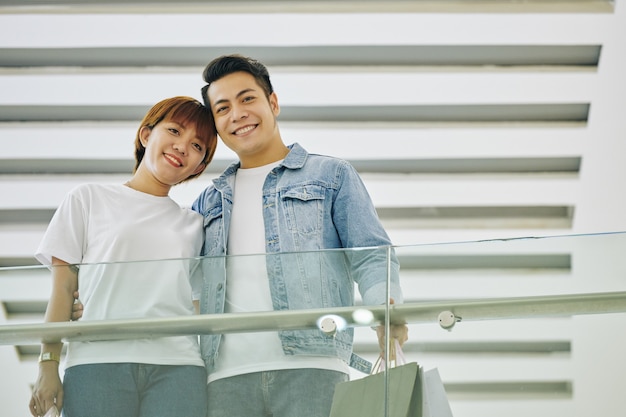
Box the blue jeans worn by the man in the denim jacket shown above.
[208,369,348,417]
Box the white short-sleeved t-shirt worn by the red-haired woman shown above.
[35,184,204,367]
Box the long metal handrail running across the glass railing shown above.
[0,292,626,345]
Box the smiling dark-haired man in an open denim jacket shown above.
[193,55,406,417]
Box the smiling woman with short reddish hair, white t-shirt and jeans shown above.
[29,97,217,417]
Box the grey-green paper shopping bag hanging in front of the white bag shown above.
[330,362,422,417]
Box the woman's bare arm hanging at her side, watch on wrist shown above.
[29,257,78,416]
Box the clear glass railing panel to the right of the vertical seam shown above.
[370,233,626,417]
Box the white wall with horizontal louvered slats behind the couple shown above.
[0,0,626,417]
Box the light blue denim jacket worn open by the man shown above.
[193,143,402,372]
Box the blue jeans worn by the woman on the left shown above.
[62,363,207,417]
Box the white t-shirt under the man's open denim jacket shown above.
[209,162,349,382]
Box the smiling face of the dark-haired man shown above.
[207,72,282,168]
